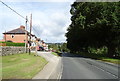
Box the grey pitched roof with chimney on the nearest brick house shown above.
[3,26,26,34]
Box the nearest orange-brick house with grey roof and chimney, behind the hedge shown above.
[3,26,28,43]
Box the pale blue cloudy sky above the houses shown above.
[0,0,74,43]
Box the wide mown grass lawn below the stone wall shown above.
[2,54,47,79]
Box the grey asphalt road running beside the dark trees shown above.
[61,53,118,81]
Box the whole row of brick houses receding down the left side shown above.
[2,26,48,49]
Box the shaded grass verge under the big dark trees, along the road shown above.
[79,52,120,64]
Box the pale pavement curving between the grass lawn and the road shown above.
[32,52,61,79]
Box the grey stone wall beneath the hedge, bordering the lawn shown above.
[0,46,25,56]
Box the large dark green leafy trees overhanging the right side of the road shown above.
[66,2,120,57]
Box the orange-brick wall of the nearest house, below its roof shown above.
[4,34,25,43]
